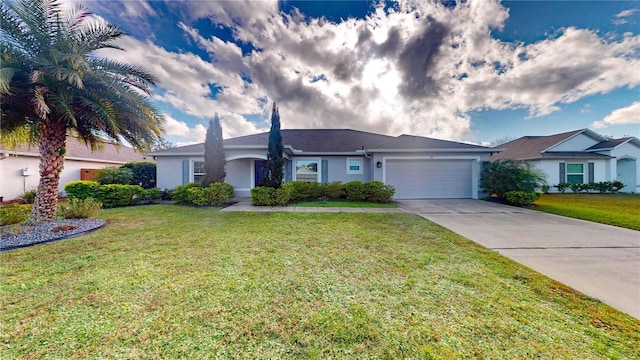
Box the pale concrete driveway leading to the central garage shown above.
[397,200,640,319]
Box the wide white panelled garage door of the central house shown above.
[385,159,473,199]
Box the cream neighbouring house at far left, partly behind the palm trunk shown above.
[0,137,152,201]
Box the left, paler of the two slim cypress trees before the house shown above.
[202,113,226,187]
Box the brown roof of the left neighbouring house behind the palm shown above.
[3,137,151,163]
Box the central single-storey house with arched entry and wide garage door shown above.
[149,129,496,199]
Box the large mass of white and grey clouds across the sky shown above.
[90,0,640,140]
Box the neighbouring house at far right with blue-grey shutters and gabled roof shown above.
[491,129,640,193]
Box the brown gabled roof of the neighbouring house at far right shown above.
[491,129,635,160]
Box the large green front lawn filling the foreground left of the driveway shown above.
[0,205,640,359]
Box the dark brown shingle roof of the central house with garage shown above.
[149,129,496,156]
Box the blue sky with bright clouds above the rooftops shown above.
[84,0,640,146]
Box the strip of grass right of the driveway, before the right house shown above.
[533,194,640,230]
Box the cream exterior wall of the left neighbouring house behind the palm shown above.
[0,155,123,201]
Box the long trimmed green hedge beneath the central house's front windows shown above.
[250,181,396,206]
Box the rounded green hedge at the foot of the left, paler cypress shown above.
[172,182,235,206]
